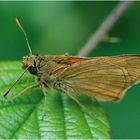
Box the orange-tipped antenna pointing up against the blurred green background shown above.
[16,18,33,55]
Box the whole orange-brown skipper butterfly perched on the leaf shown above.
[4,19,140,117]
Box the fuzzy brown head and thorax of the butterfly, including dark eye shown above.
[22,55,71,92]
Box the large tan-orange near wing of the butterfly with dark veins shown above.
[59,55,140,101]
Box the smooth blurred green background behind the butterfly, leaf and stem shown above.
[0,1,140,138]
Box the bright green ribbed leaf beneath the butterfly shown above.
[0,62,110,139]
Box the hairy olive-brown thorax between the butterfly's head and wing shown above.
[37,57,70,92]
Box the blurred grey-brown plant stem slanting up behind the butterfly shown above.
[77,1,132,56]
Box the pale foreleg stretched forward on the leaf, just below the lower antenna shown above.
[6,84,39,102]
